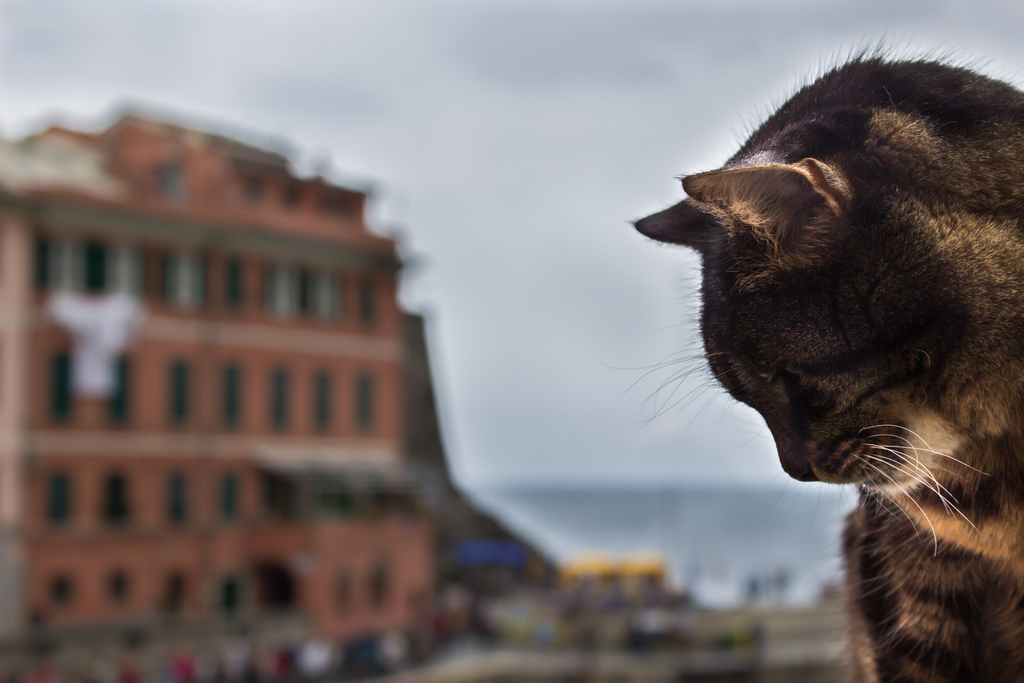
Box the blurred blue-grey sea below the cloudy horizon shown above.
[471,484,857,608]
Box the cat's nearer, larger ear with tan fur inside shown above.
[683,159,850,260]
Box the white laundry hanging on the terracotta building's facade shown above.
[49,292,144,398]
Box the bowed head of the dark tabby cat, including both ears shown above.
[636,154,1024,489]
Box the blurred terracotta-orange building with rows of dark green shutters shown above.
[0,116,433,638]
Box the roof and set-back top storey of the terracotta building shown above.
[0,114,394,254]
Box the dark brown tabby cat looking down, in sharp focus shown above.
[635,53,1024,683]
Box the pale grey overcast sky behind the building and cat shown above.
[0,0,1024,485]
